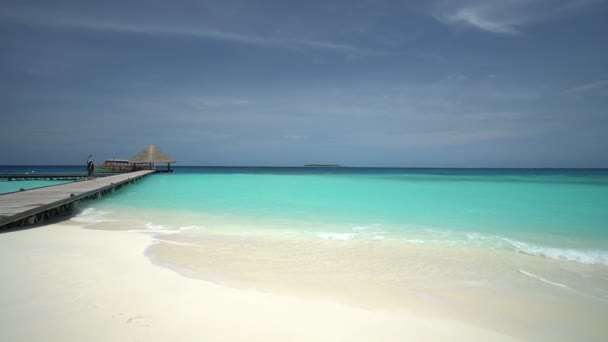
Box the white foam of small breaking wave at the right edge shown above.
[502,238,608,266]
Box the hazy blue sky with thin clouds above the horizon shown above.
[0,0,608,167]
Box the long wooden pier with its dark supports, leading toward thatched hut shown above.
[0,170,155,230]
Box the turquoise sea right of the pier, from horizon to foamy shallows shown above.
[86,168,608,266]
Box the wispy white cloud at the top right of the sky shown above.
[433,0,601,34]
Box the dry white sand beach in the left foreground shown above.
[0,223,514,341]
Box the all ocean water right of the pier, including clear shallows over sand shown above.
[72,167,608,341]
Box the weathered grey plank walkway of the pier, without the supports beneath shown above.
[0,170,154,227]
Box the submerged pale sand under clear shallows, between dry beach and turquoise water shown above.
[145,229,608,341]
